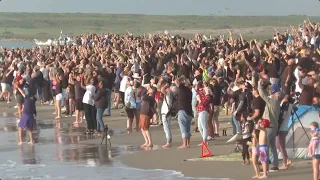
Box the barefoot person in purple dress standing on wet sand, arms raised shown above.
[16,84,36,145]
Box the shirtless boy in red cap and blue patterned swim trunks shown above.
[253,119,270,179]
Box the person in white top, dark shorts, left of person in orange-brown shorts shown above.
[124,78,136,133]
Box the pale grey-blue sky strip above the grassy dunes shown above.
[0,0,320,16]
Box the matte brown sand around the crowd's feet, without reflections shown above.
[0,103,312,180]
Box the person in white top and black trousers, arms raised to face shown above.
[81,78,97,134]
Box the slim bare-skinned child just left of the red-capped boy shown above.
[251,129,260,178]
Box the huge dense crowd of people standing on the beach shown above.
[0,20,320,178]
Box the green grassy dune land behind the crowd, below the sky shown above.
[0,12,320,40]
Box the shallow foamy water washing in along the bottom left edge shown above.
[0,160,231,180]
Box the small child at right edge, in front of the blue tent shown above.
[308,122,320,180]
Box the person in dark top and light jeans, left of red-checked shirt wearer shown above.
[175,77,193,149]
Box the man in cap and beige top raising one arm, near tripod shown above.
[258,80,280,172]
